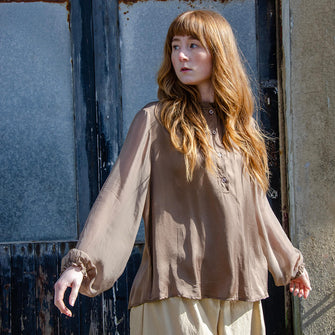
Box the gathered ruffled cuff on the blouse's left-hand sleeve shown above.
[61,249,96,278]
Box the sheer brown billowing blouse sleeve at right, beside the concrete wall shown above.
[256,187,303,286]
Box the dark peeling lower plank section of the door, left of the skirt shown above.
[0,242,142,335]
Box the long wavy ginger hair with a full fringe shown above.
[157,10,269,191]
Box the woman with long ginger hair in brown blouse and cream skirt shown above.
[55,10,311,334]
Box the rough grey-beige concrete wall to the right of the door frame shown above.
[281,0,335,335]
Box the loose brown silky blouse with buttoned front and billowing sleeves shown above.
[62,102,303,307]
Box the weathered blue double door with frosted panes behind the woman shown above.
[0,0,289,334]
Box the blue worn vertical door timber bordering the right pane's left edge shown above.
[92,0,123,186]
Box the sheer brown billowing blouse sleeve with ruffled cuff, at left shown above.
[62,110,151,296]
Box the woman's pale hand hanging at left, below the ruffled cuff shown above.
[54,266,84,316]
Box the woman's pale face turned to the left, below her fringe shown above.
[171,35,213,100]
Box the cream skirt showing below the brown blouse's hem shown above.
[130,297,265,335]
